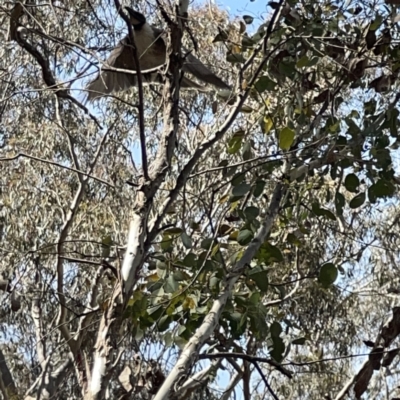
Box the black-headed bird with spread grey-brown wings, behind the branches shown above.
[86,7,231,101]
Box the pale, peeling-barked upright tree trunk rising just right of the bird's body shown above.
[89,4,186,400]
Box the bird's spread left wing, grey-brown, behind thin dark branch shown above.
[86,39,136,101]
